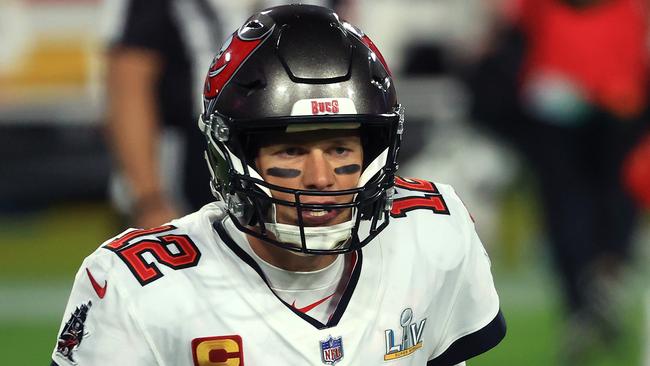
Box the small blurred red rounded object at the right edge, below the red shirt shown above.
[623,133,650,209]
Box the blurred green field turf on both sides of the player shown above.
[0,204,646,366]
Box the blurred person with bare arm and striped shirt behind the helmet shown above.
[104,0,332,228]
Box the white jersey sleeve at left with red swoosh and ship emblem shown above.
[52,249,160,366]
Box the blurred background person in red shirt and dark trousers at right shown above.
[472,0,650,364]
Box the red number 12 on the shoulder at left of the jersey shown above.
[104,225,201,286]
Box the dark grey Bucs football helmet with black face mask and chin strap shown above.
[199,5,404,254]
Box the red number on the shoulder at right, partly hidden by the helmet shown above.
[390,177,449,217]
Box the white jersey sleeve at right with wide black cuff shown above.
[427,187,506,366]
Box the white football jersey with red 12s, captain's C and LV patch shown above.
[52,178,505,366]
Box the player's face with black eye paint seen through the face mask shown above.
[255,130,363,226]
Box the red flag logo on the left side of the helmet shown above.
[203,14,275,101]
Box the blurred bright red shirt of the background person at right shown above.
[514,0,648,118]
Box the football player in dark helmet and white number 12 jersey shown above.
[52,5,505,366]
